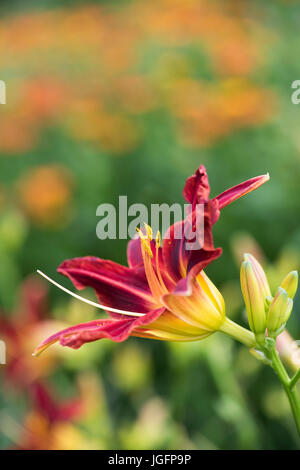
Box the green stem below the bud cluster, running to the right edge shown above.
[266,342,300,436]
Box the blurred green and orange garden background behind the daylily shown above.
[0,0,300,449]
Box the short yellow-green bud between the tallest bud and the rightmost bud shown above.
[267,287,293,338]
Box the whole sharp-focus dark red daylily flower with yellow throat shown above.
[35,165,269,354]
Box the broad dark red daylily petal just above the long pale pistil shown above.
[57,256,156,313]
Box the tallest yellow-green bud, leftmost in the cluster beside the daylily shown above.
[241,260,266,343]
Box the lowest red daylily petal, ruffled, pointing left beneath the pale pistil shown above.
[34,308,165,355]
